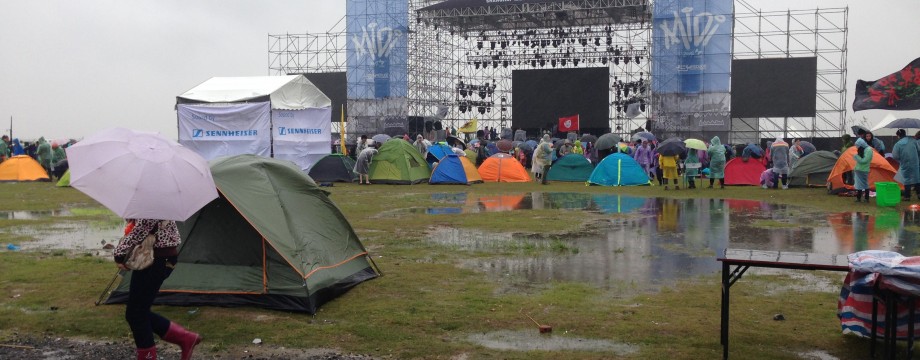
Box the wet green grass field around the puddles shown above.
[0,183,907,360]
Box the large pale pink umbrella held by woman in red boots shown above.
[67,128,217,221]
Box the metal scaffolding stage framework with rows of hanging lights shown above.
[268,0,847,143]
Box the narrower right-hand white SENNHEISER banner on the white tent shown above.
[272,108,332,172]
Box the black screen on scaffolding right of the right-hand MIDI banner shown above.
[731,57,818,118]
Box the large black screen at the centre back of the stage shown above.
[511,67,610,137]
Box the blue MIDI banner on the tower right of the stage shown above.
[652,0,733,94]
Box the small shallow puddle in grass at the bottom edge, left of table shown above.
[468,329,639,356]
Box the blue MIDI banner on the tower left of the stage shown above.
[345,0,409,99]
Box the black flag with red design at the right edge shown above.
[853,58,920,111]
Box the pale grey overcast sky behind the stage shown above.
[0,0,920,139]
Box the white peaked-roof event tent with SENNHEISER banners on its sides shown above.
[176,75,332,171]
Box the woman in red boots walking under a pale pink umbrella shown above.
[66,129,218,360]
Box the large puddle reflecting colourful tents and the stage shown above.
[429,193,920,290]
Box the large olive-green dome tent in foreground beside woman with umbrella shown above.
[106,155,377,314]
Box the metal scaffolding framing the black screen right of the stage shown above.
[730,0,849,143]
